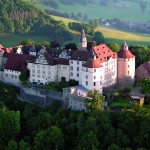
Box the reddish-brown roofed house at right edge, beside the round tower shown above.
[135,61,150,81]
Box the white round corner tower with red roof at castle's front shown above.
[82,50,103,93]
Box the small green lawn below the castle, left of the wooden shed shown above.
[108,96,130,107]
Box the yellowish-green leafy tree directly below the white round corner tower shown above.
[85,89,105,111]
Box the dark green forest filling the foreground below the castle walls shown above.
[0,83,150,150]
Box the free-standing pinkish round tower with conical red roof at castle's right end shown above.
[117,41,135,87]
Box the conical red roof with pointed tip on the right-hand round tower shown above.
[118,42,135,58]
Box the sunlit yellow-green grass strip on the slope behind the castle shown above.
[52,16,150,45]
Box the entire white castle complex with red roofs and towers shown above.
[0,29,135,93]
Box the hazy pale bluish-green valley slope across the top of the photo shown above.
[25,0,150,22]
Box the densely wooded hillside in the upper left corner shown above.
[0,0,72,40]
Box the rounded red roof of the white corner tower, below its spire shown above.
[83,59,103,68]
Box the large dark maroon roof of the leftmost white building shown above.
[4,53,35,72]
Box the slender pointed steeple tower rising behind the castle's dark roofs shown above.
[78,28,87,50]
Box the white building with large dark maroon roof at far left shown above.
[0,52,35,84]
